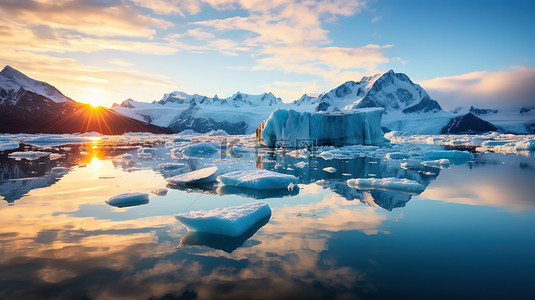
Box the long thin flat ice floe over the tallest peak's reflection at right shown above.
[347,177,425,194]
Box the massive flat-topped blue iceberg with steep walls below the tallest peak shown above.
[256,108,385,148]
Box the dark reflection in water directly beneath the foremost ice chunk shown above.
[178,215,271,253]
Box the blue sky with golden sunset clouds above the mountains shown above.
[0,0,535,109]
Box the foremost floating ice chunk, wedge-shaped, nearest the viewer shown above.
[175,201,271,236]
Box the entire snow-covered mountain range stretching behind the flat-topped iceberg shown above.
[113,70,531,134]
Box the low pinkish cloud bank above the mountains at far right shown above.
[419,66,535,109]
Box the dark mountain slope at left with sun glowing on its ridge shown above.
[0,66,171,134]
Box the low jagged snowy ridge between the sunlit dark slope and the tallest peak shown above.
[112,91,287,134]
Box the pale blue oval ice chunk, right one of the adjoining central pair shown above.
[217,170,298,189]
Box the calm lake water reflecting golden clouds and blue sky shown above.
[0,138,535,299]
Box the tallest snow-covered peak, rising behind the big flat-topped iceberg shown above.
[315,70,442,114]
